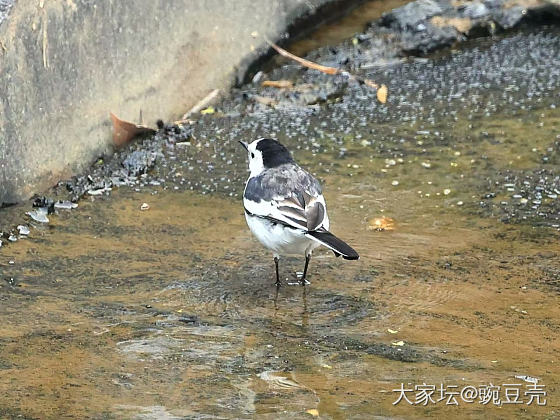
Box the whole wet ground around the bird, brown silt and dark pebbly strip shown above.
[0,1,560,419]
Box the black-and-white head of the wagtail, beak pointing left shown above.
[239,138,294,176]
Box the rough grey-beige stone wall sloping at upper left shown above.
[0,0,360,205]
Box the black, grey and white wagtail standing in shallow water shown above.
[240,138,359,286]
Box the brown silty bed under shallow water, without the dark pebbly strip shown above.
[0,14,560,418]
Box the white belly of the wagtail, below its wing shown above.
[245,213,320,255]
